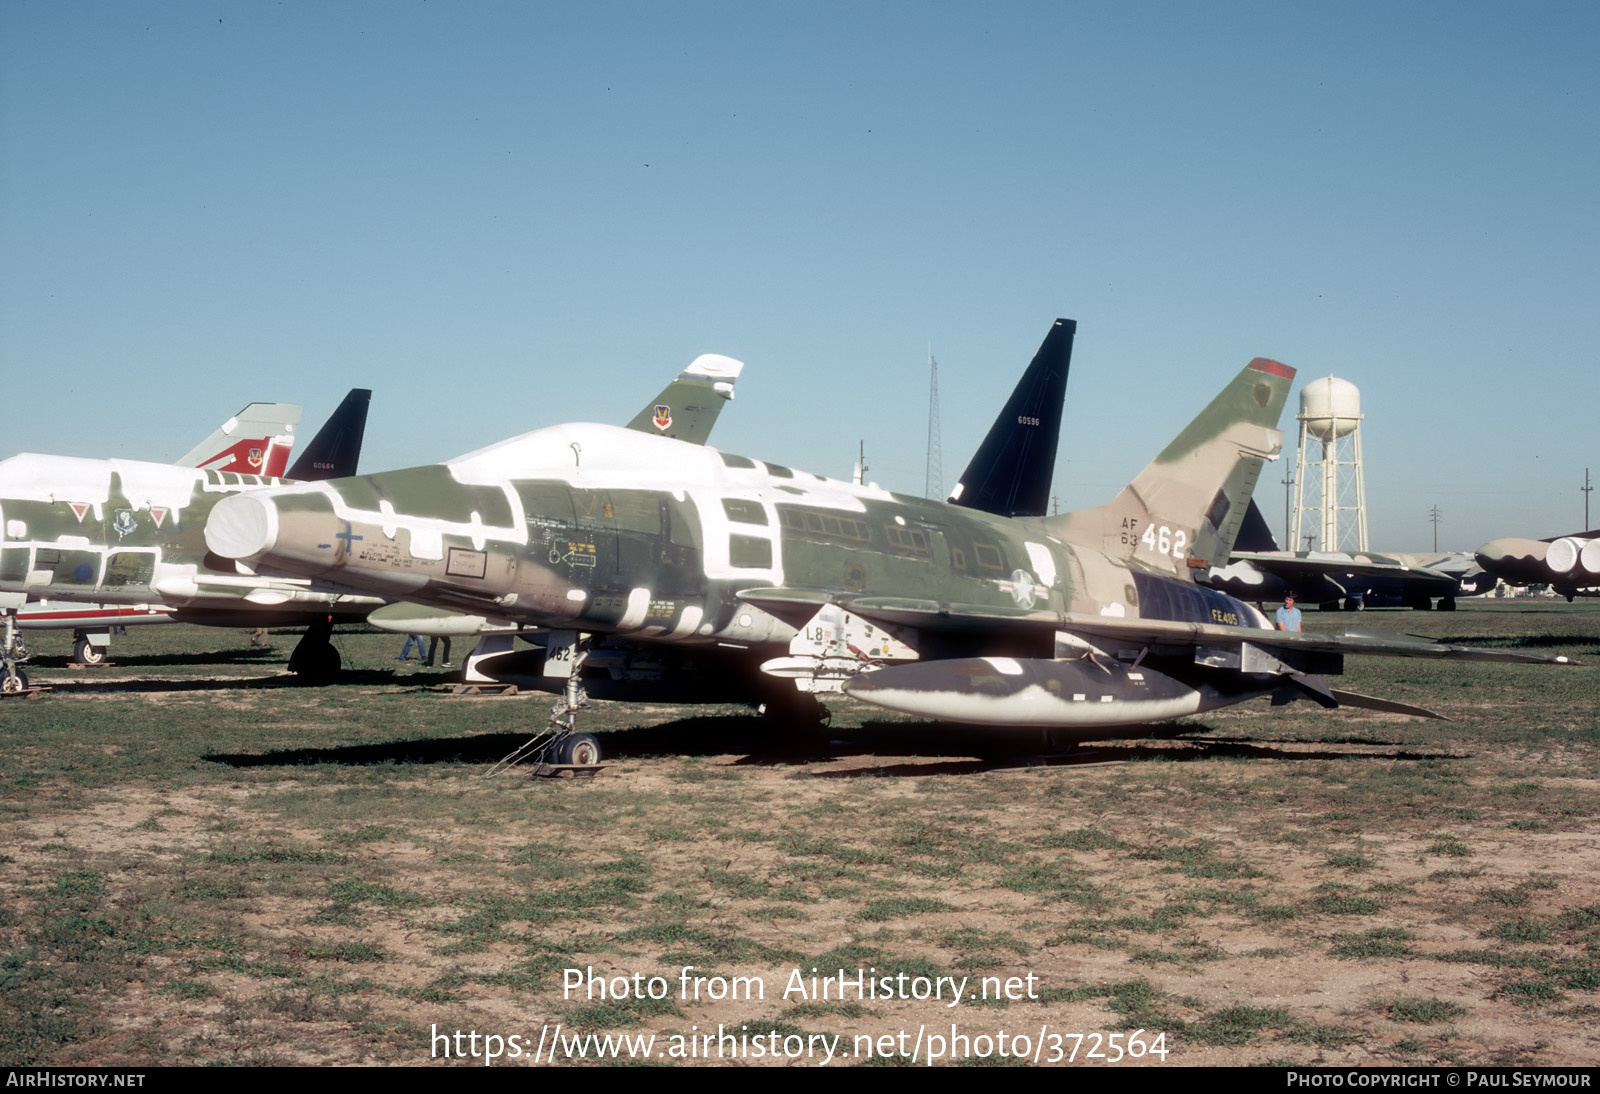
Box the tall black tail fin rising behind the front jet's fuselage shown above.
[950,320,1078,517]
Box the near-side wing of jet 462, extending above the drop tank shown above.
[812,590,1576,664]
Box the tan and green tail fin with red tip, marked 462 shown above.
[1051,357,1294,576]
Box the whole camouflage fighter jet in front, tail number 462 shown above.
[206,320,1552,757]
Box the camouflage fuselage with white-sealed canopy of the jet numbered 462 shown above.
[206,424,1267,657]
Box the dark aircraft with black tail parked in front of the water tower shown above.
[1202,501,1499,611]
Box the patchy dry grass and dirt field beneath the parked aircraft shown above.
[0,601,1600,1067]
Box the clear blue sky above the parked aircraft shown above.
[0,0,1600,550]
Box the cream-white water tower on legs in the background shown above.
[1288,376,1366,550]
